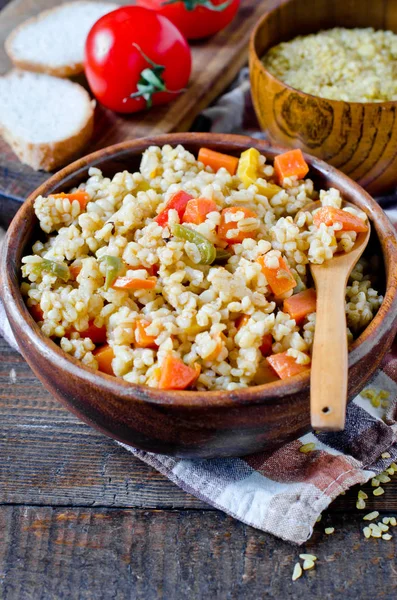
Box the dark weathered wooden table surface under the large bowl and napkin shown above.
[0,0,397,600]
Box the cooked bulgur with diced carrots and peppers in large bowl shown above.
[21,145,382,390]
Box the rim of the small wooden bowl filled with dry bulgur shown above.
[250,0,397,109]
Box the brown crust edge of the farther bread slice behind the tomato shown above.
[4,0,117,78]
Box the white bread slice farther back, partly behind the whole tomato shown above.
[5,0,118,77]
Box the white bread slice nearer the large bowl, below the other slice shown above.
[0,70,95,171]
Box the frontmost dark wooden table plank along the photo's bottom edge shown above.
[0,507,397,600]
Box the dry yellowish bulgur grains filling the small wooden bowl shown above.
[263,27,397,102]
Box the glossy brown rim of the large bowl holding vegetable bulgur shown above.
[0,133,397,409]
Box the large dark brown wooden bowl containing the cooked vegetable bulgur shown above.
[0,133,397,458]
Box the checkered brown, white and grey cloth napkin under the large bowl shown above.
[0,73,397,544]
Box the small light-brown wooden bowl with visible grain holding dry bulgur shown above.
[250,0,397,195]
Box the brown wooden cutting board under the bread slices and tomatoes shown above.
[0,0,277,204]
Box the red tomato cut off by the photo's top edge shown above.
[137,0,240,40]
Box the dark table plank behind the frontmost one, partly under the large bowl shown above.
[0,338,397,512]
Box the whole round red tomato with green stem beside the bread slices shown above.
[85,6,191,113]
